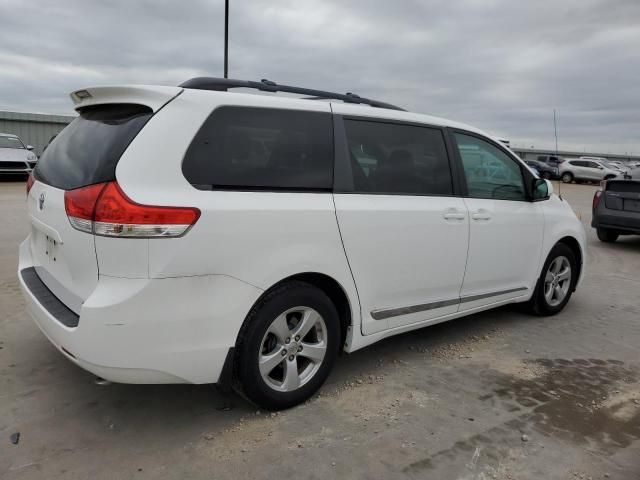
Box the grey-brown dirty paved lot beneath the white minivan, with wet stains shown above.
[0,181,640,480]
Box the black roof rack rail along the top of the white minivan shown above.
[179,77,404,111]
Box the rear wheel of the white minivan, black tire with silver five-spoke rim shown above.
[233,281,341,410]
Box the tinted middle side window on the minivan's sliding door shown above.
[344,119,453,195]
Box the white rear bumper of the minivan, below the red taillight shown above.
[18,238,262,383]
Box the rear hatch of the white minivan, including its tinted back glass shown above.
[27,87,180,314]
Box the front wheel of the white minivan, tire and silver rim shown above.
[526,243,578,316]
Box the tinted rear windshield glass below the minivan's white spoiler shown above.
[34,104,153,190]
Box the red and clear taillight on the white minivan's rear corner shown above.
[64,182,200,238]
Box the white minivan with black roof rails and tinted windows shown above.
[18,78,586,409]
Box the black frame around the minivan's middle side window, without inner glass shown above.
[333,113,462,198]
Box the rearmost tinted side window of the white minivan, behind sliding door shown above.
[182,107,333,190]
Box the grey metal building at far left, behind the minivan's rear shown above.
[0,111,75,156]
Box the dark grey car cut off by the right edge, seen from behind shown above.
[591,168,640,242]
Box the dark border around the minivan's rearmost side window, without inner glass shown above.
[180,103,336,193]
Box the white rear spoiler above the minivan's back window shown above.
[69,85,183,113]
